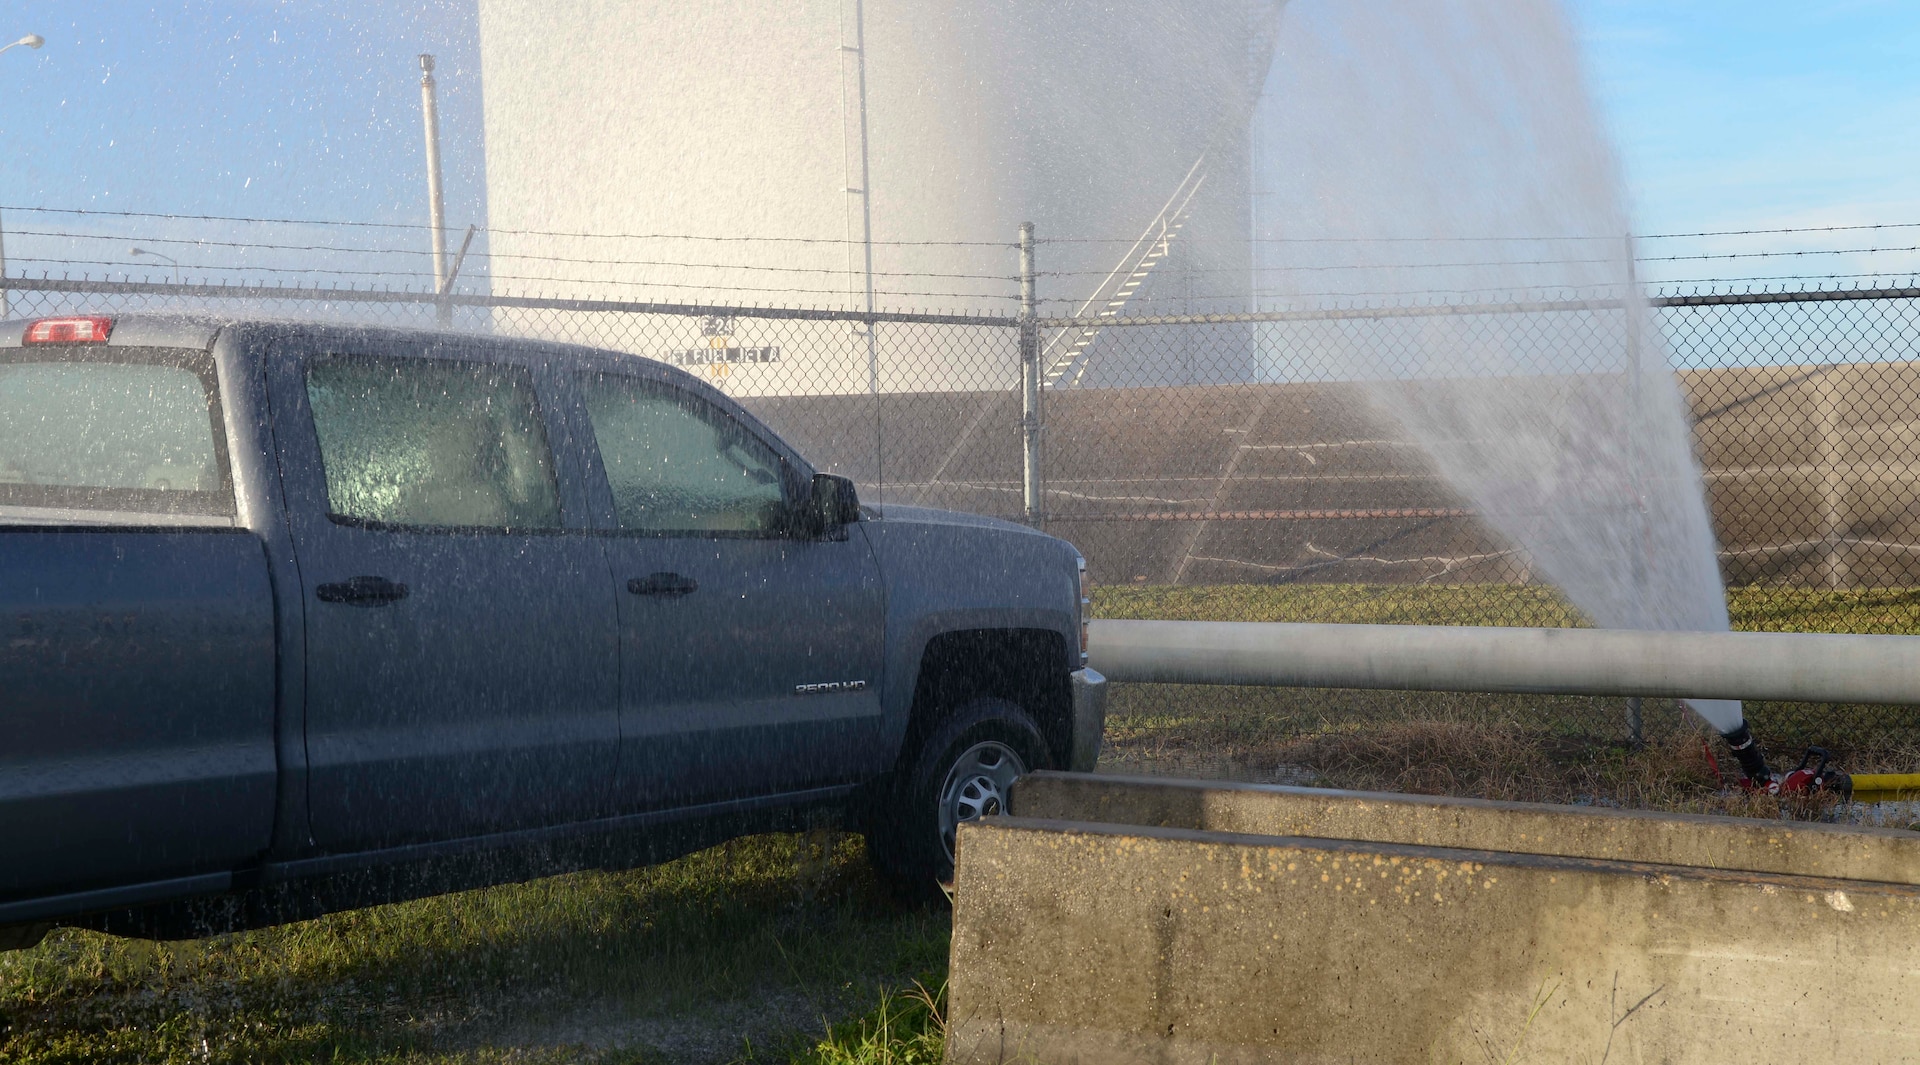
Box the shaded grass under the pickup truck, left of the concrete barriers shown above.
[0,837,947,1065]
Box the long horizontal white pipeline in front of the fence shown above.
[1089,622,1920,702]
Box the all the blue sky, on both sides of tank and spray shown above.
[0,0,1920,287]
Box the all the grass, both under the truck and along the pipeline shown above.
[0,585,1920,1065]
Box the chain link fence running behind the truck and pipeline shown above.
[6,278,1920,777]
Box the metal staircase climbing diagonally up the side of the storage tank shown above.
[1041,0,1286,388]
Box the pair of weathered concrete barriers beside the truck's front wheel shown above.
[948,773,1920,1065]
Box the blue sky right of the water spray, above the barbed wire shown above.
[1571,0,1920,232]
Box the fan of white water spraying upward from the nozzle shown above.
[1254,0,1741,731]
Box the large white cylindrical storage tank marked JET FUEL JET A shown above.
[480,0,1271,395]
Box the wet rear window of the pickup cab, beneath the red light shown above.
[0,347,234,520]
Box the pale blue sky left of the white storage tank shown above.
[0,0,484,223]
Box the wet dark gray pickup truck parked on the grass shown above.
[0,317,1104,946]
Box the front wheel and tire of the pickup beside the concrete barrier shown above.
[868,697,1048,902]
